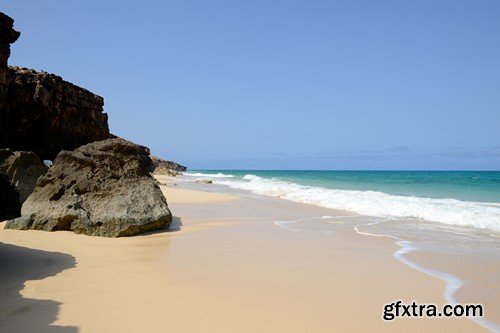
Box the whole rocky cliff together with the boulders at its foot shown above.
[0,13,186,237]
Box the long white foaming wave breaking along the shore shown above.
[215,175,500,231]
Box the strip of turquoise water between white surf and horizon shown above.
[193,170,500,203]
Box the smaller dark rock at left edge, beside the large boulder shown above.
[0,149,48,204]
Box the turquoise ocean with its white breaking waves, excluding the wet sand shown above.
[186,170,500,233]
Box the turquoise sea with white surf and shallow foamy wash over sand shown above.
[182,170,500,332]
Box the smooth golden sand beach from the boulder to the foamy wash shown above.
[0,178,492,332]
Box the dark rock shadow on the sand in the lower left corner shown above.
[0,243,78,333]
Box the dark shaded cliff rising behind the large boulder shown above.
[0,13,111,160]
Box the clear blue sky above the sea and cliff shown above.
[0,0,500,170]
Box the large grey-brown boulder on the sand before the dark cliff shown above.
[6,138,172,237]
